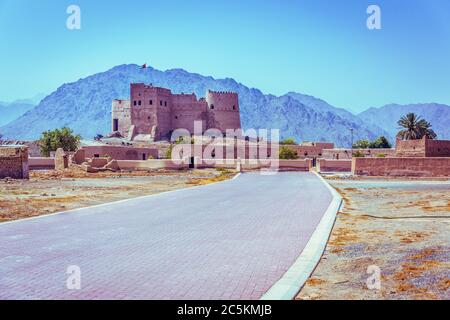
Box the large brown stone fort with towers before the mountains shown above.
[112,83,241,141]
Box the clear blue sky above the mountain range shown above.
[0,0,450,112]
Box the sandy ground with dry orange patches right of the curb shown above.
[297,178,450,300]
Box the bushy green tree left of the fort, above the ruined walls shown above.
[38,127,81,157]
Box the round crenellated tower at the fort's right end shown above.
[205,90,241,133]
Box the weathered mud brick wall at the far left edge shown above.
[0,146,29,179]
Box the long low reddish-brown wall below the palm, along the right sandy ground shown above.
[352,158,450,177]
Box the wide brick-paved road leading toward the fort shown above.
[0,173,331,299]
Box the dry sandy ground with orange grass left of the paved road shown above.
[0,168,235,222]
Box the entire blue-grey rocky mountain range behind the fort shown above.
[0,64,450,147]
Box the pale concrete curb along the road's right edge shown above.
[261,172,342,300]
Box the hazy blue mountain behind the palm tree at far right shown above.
[358,103,450,141]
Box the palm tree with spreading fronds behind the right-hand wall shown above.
[397,113,437,140]
